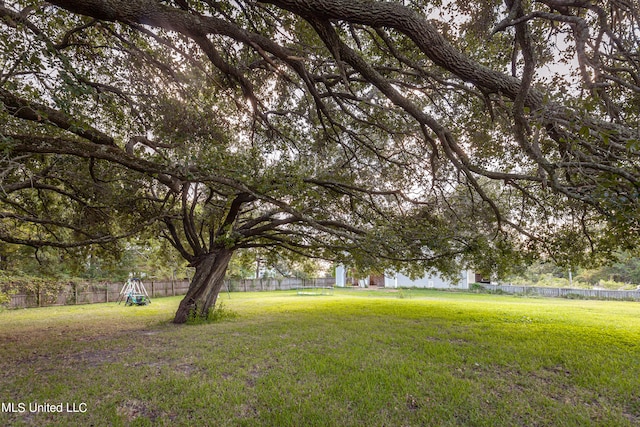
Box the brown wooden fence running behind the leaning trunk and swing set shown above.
[7,278,335,308]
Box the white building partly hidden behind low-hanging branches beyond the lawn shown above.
[336,265,478,289]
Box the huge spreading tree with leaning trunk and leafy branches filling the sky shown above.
[0,0,640,322]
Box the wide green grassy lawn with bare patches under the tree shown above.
[0,290,640,426]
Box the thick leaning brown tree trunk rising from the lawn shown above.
[173,248,233,323]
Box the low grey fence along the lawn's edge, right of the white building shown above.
[482,283,640,301]
